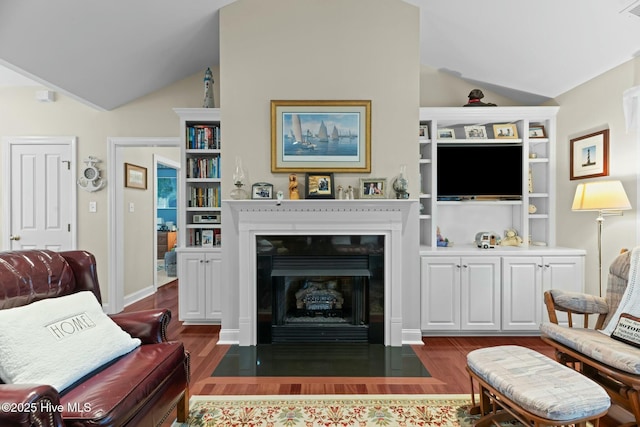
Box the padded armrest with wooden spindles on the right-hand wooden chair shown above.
[544,289,609,329]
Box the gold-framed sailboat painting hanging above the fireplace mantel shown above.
[271,100,371,172]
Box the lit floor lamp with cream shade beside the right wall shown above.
[571,181,631,296]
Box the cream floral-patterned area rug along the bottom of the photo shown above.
[172,394,477,427]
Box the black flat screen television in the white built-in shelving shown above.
[436,143,522,200]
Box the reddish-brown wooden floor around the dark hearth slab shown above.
[125,281,553,425]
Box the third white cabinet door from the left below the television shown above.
[502,256,543,331]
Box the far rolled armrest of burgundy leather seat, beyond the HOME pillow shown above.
[109,308,171,344]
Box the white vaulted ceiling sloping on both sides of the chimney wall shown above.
[0,0,640,110]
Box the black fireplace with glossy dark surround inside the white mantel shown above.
[256,235,384,344]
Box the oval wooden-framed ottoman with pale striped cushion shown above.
[467,345,611,426]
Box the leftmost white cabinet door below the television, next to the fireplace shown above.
[420,257,461,331]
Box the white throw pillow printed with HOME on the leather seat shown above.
[0,291,140,392]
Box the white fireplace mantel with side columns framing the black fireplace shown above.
[219,199,422,346]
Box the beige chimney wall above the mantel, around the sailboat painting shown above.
[220,0,420,197]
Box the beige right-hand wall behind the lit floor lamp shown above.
[556,59,640,294]
